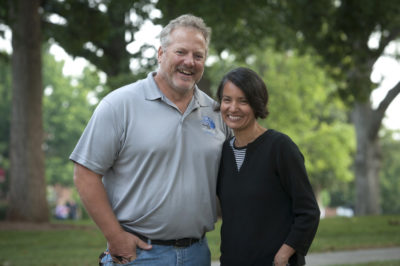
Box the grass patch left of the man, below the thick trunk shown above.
[0,221,105,266]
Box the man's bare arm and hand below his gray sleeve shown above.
[74,163,151,263]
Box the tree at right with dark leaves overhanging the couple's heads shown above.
[157,0,400,215]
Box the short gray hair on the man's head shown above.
[160,14,211,50]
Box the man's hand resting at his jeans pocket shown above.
[108,231,152,264]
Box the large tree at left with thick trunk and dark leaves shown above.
[0,0,156,222]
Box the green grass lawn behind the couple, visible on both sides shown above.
[0,215,400,266]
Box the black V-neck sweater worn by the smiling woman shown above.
[217,129,320,266]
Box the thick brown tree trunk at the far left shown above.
[7,0,49,222]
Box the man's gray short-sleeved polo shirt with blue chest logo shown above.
[70,73,229,239]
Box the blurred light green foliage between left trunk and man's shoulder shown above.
[43,53,102,185]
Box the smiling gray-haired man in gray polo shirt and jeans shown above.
[70,15,230,266]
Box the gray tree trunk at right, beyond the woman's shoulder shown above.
[352,103,381,215]
